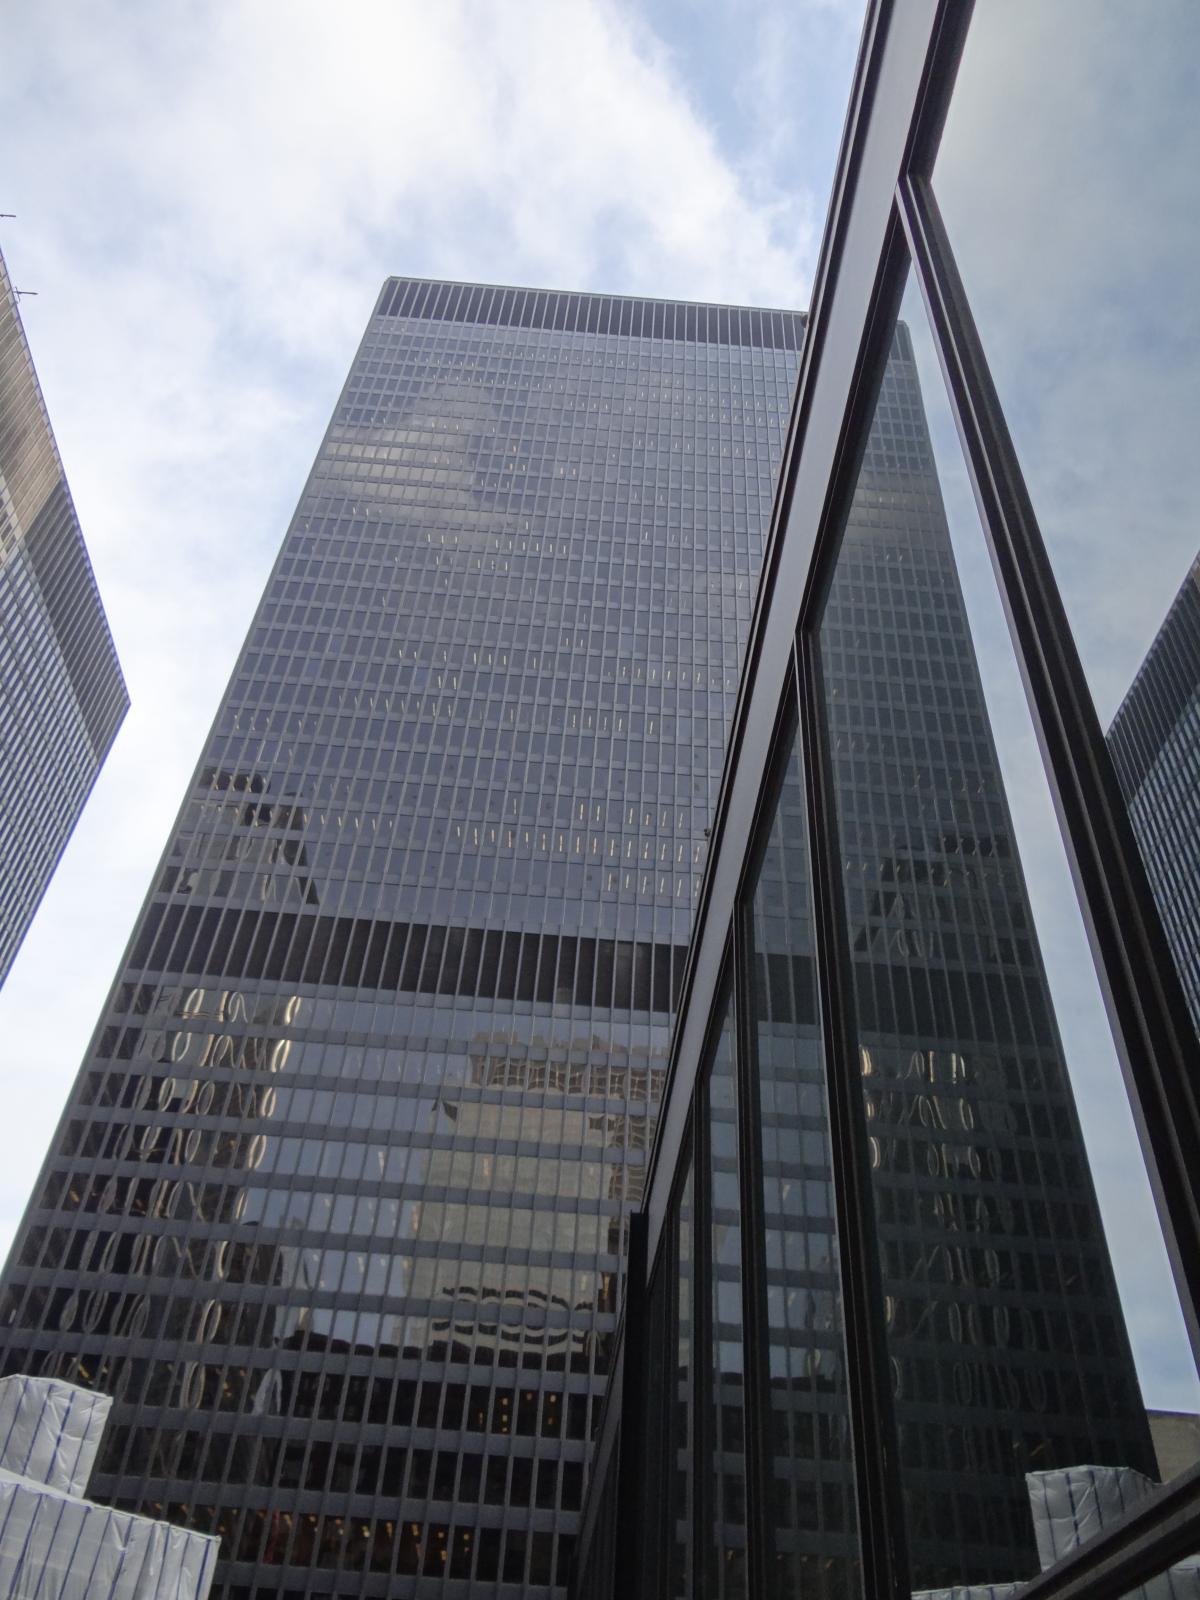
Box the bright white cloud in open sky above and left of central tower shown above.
[0,0,853,1246]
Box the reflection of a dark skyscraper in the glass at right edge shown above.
[1107,557,1200,1029]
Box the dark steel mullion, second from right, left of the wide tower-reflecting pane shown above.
[797,624,912,1600]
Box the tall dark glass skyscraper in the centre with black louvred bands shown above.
[2,280,802,1600]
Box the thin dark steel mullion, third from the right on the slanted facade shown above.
[733,896,778,1595]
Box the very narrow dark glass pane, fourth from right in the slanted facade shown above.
[707,1011,746,1600]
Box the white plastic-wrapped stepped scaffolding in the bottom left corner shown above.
[0,1378,219,1600]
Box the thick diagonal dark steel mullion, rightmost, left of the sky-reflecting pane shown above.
[896,176,1200,1358]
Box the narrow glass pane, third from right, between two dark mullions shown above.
[752,730,859,1600]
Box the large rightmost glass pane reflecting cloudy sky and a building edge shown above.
[934,0,1200,1021]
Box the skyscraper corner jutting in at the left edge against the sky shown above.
[0,244,130,982]
